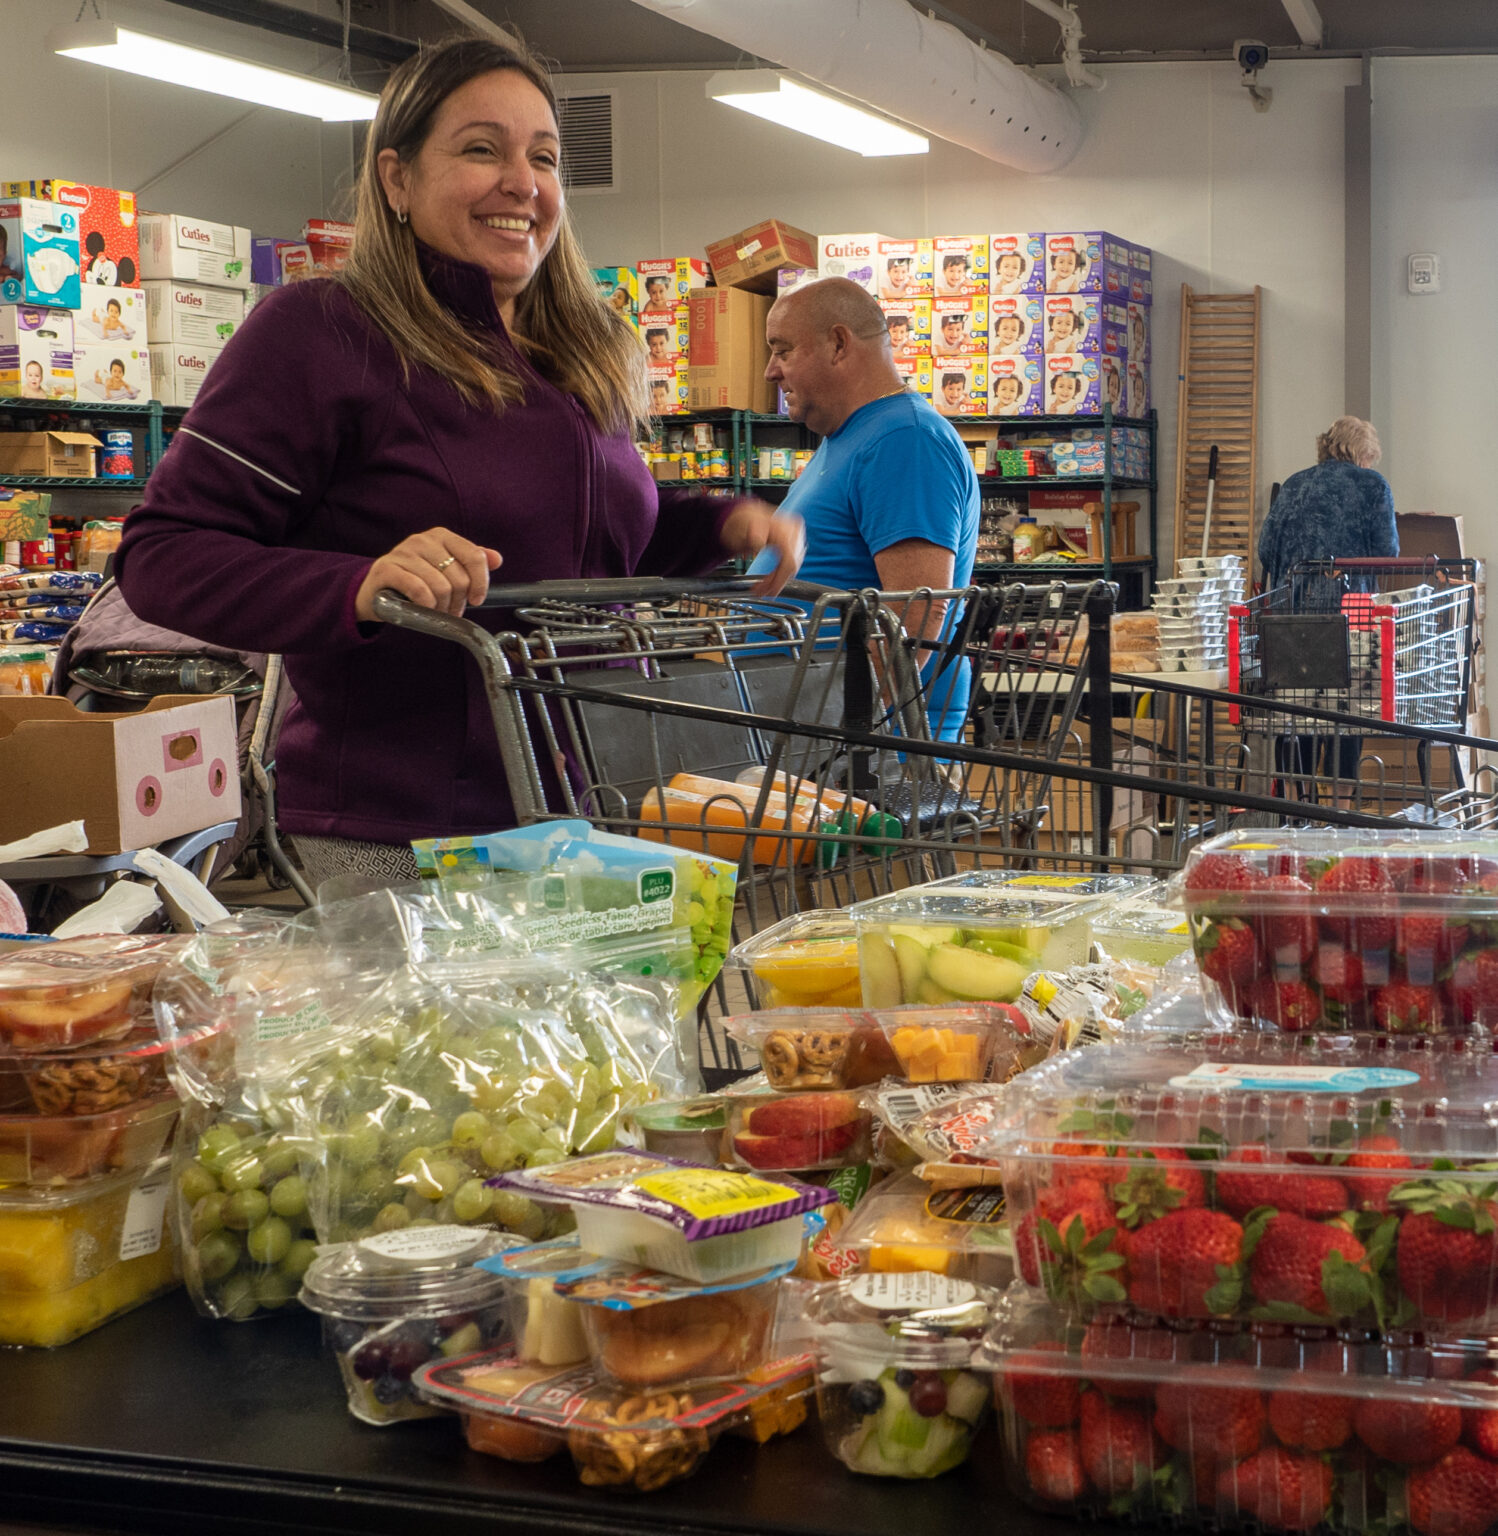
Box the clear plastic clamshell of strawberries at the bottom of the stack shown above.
[979,1298,1498,1536]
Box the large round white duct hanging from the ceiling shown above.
[635,0,1082,170]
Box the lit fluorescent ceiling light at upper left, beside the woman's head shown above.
[48,22,379,123]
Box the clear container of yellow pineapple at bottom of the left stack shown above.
[0,1161,178,1347]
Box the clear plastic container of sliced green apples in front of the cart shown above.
[853,869,1151,1008]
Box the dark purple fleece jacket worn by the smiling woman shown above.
[117,249,733,843]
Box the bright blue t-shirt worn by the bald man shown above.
[754,393,979,742]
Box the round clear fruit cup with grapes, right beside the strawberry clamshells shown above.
[807,1273,997,1478]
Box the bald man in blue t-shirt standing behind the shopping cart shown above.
[765,278,979,740]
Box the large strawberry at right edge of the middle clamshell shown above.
[1389,1178,1498,1322]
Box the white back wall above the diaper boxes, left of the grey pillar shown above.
[564,60,1358,556]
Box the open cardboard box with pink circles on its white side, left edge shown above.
[0,694,240,854]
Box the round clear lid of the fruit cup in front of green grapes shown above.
[301,1226,525,1322]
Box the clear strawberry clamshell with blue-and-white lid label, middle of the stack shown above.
[989,1032,1498,1332]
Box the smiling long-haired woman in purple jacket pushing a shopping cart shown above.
[118,38,800,879]
